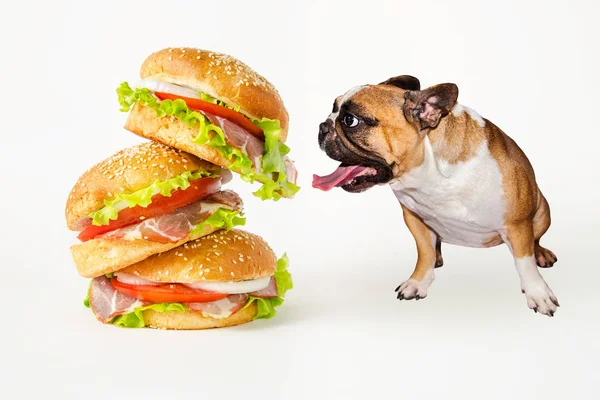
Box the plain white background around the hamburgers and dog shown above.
[0,0,600,399]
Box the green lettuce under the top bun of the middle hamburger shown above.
[88,170,213,226]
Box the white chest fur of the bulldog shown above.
[390,138,505,247]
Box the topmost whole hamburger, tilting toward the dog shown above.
[117,48,299,200]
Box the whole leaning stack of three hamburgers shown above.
[65,48,299,329]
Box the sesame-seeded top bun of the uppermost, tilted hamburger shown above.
[140,47,288,142]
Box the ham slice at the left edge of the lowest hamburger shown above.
[90,275,142,323]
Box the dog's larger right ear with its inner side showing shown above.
[403,83,458,129]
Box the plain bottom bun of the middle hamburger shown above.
[71,219,230,278]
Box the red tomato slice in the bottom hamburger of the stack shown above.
[110,278,229,303]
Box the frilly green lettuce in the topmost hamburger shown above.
[116,82,300,202]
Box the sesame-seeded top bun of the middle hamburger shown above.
[65,142,221,230]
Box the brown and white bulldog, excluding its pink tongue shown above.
[319,75,559,316]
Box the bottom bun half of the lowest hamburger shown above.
[144,302,258,330]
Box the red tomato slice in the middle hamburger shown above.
[77,178,221,242]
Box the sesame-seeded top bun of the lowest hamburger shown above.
[119,229,277,283]
